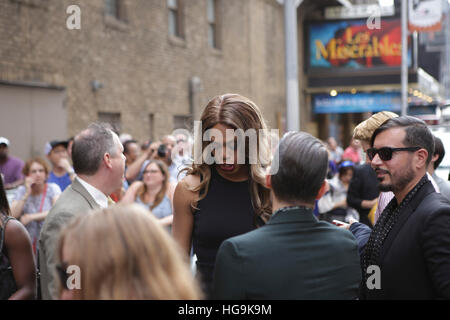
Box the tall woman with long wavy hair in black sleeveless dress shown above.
[173,94,271,297]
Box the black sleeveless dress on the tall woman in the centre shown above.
[192,166,264,299]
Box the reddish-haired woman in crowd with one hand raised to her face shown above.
[11,158,61,256]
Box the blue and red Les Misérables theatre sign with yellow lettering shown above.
[308,18,411,69]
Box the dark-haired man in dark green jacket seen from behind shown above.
[213,132,361,299]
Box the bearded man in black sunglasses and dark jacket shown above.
[360,116,450,299]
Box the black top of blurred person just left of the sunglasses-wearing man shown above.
[347,164,380,226]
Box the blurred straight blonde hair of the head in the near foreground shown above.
[58,204,201,300]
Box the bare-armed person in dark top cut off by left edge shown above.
[0,175,36,300]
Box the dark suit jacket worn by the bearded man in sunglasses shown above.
[362,182,450,299]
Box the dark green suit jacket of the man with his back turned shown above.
[213,209,361,299]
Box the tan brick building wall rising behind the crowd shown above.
[0,0,285,140]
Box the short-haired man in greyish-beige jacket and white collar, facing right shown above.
[39,124,125,300]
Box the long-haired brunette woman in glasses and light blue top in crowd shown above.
[121,160,175,226]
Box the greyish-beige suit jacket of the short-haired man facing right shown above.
[39,178,100,300]
